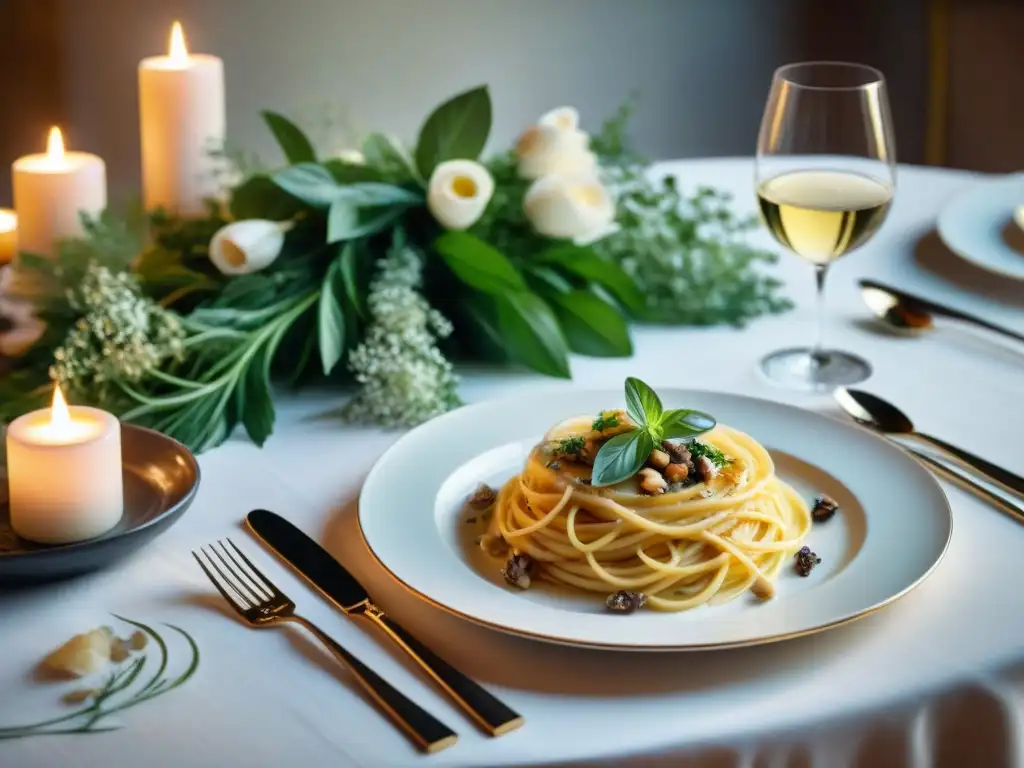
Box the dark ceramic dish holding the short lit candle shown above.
[0,424,200,587]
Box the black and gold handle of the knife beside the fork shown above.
[360,604,523,736]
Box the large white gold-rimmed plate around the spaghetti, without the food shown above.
[358,389,952,650]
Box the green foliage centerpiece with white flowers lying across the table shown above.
[0,87,788,452]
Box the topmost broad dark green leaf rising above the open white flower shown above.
[416,86,490,179]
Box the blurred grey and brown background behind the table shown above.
[0,0,1024,205]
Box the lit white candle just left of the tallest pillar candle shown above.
[11,126,106,256]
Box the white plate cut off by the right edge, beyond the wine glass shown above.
[938,173,1024,280]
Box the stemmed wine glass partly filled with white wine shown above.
[755,61,896,391]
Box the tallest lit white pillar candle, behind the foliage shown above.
[138,22,225,216]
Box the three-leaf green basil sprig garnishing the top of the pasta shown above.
[591,377,717,486]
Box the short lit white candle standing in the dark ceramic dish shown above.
[7,387,124,544]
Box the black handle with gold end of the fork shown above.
[289,615,459,752]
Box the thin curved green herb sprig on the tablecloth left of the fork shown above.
[0,613,200,740]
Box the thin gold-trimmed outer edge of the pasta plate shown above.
[355,386,954,653]
